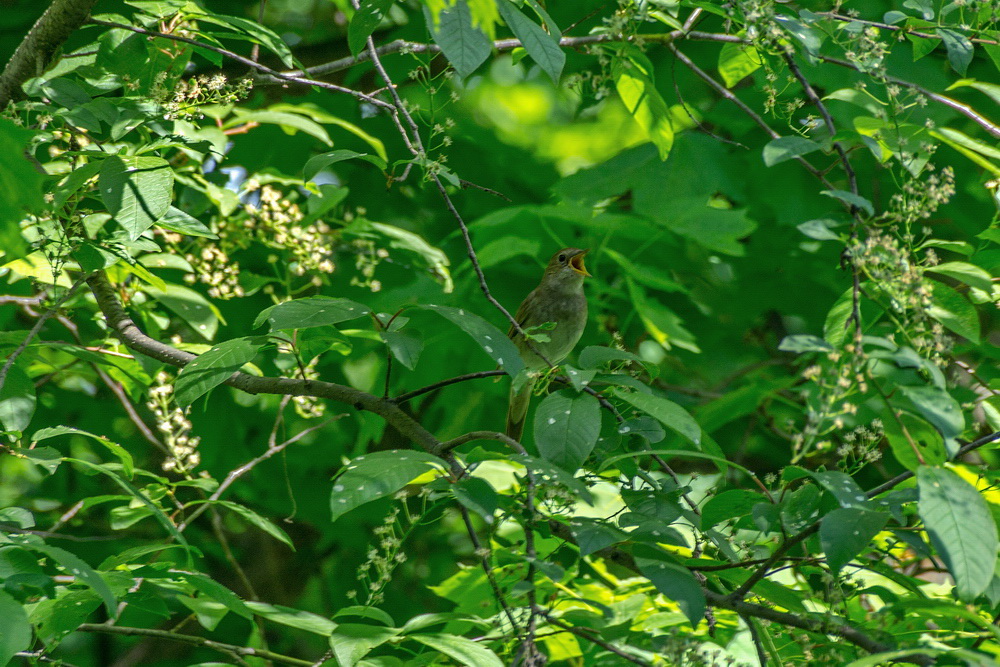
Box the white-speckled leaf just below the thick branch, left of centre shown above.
[330,449,446,521]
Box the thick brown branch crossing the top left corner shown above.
[0,0,97,109]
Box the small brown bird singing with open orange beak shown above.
[505,248,590,441]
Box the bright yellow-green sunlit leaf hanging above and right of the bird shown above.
[611,44,674,160]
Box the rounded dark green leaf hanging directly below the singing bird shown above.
[534,389,601,472]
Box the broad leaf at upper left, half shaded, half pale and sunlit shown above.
[98,155,174,241]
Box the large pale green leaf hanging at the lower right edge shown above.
[917,467,1000,602]
